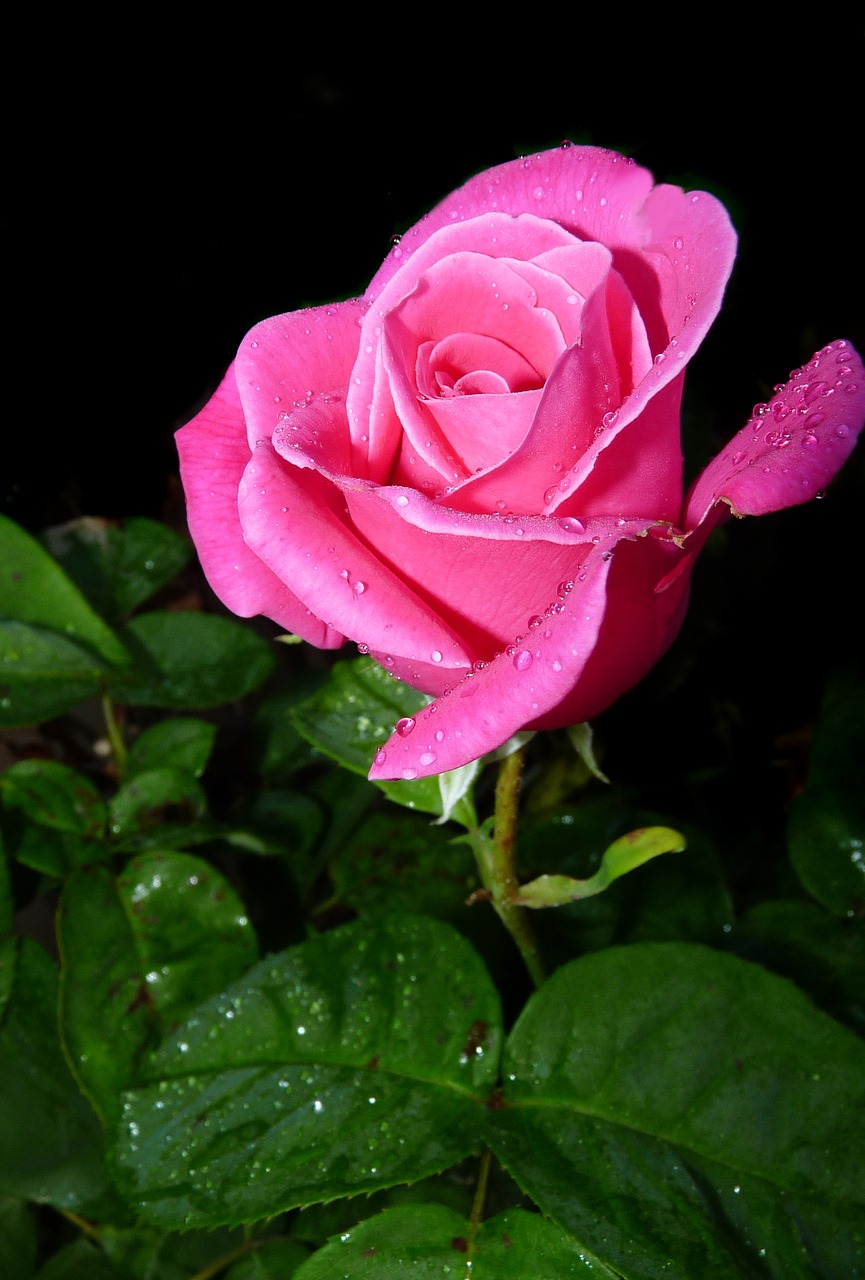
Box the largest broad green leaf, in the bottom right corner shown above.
[489,943,865,1280]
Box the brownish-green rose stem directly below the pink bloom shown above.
[477,751,546,987]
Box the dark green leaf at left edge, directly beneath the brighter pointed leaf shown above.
[0,620,107,728]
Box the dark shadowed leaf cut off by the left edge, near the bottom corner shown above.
[0,938,106,1215]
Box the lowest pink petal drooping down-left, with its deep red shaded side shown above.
[370,519,687,780]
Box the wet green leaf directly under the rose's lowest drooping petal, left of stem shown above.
[292,658,479,824]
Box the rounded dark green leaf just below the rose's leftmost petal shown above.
[109,613,274,710]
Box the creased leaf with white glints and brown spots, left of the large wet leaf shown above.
[58,852,257,1123]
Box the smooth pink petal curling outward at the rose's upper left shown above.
[234,298,369,449]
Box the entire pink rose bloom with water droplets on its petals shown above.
[178,146,865,778]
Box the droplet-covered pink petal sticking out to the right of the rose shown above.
[683,340,865,541]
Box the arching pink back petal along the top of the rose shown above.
[367,147,736,371]
